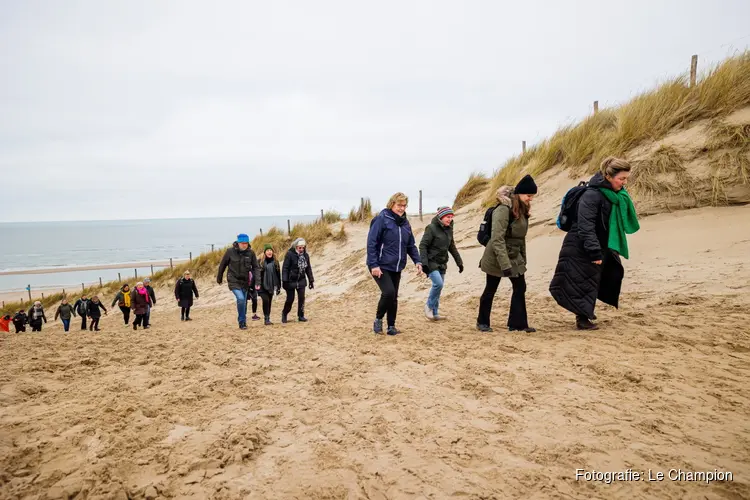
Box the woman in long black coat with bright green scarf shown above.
[549,157,640,330]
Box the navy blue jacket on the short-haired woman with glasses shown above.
[367,209,422,273]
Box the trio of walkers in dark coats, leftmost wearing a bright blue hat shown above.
[216,233,315,330]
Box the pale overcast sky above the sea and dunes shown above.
[0,0,750,221]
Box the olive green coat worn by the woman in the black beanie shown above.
[479,204,529,278]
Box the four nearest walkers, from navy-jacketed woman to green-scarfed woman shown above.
[367,157,639,335]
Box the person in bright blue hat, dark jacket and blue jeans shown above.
[216,233,260,330]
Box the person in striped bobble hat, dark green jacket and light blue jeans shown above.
[419,207,464,321]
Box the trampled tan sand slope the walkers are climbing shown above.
[0,197,750,499]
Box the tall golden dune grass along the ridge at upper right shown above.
[476,51,750,205]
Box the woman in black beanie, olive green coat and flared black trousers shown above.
[477,175,537,333]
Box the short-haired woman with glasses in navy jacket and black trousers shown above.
[367,193,422,335]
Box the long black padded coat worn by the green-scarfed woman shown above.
[549,173,625,319]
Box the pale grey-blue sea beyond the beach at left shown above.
[0,215,316,292]
